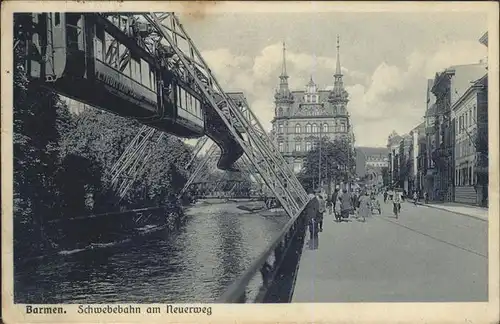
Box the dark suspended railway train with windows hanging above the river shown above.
[21,13,243,170]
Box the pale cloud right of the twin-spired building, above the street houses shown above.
[346,41,486,146]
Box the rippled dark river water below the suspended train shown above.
[14,203,288,303]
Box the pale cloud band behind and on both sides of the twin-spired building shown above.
[202,40,486,146]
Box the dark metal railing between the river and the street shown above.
[217,196,310,303]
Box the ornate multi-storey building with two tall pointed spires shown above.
[271,37,354,172]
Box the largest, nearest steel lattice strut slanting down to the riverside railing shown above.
[143,12,309,217]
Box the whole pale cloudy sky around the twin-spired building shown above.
[181,12,487,146]
